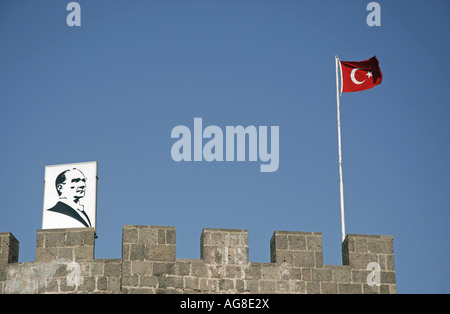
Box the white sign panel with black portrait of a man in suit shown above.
[42,161,97,229]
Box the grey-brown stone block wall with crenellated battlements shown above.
[0,225,396,294]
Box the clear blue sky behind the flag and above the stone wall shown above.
[0,0,450,293]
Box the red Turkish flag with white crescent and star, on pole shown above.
[339,56,383,93]
